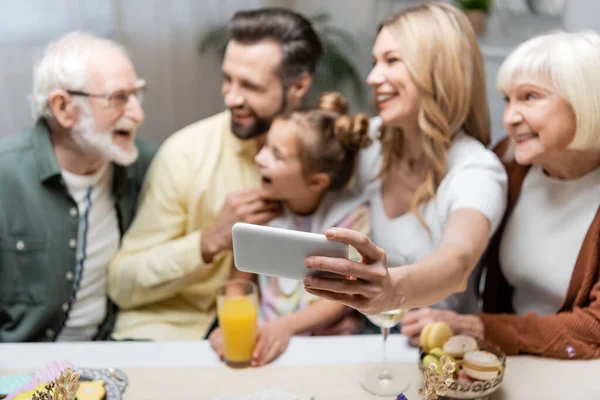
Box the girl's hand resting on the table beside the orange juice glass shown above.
[252,319,293,367]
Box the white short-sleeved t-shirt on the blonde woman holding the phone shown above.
[357,119,508,313]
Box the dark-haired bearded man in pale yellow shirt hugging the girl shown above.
[109,8,323,340]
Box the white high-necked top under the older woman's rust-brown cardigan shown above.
[500,166,600,315]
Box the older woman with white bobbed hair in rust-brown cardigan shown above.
[404,32,600,358]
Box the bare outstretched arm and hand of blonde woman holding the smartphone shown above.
[304,209,491,314]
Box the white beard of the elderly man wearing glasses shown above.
[71,103,139,166]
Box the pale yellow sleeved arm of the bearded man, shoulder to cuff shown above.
[108,142,210,308]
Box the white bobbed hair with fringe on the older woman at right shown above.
[497,31,600,149]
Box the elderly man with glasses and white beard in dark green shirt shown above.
[0,32,156,342]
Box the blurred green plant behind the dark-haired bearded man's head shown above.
[198,13,364,105]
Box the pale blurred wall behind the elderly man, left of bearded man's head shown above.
[0,0,264,142]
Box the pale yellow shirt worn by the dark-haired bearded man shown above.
[108,112,259,340]
